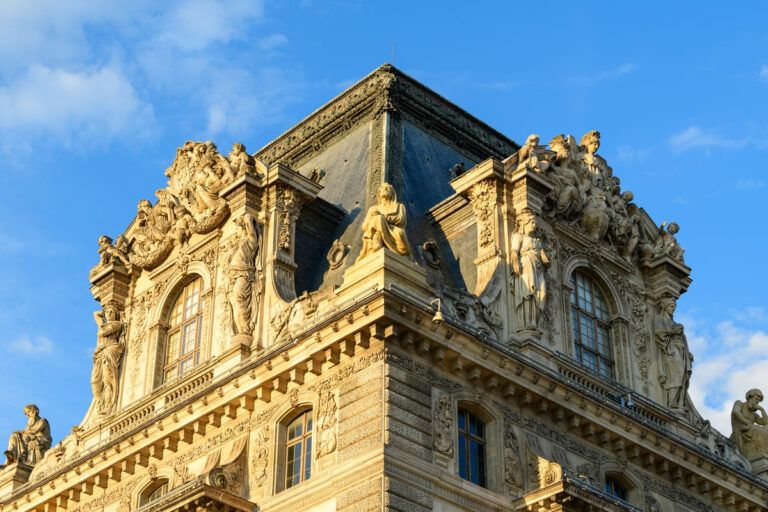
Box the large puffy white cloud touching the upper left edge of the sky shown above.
[0,66,154,144]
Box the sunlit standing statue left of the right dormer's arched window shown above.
[510,210,549,331]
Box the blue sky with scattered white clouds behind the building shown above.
[0,0,768,439]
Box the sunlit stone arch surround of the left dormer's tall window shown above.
[148,270,213,389]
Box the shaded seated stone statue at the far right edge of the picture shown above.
[731,389,768,461]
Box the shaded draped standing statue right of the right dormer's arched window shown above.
[653,297,693,410]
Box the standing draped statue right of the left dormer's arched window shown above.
[227,213,261,336]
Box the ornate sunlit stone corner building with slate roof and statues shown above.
[0,66,768,512]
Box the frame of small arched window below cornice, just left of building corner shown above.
[275,404,317,493]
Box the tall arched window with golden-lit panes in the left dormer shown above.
[163,277,205,382]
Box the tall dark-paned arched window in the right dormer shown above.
[571,272,614,379]
